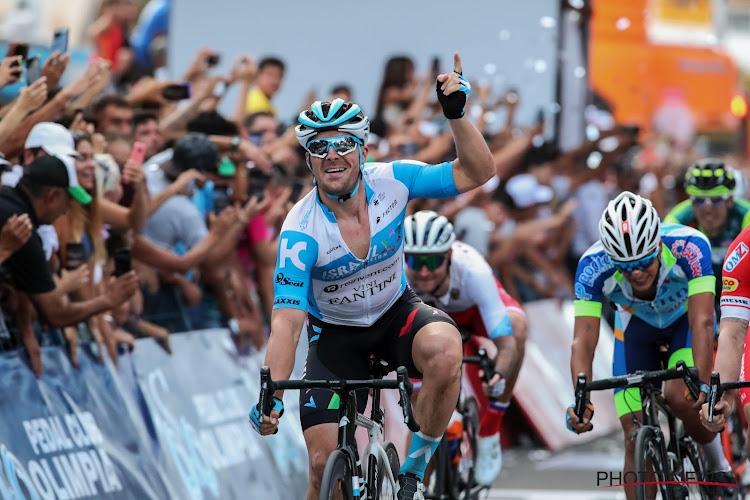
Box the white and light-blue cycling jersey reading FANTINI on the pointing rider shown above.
[273,160,458,326]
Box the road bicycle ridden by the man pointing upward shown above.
[260,358,419,500]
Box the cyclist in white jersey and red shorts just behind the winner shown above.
[404,210,527,486]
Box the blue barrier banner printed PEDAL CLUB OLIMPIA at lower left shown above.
[0,345,171,500]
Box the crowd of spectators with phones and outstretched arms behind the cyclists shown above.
[0,0,744,376]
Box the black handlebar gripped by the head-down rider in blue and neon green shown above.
[574,361,700,421]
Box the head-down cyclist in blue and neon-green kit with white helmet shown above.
[565,191,733,499]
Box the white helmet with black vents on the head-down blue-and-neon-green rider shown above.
[599,191,661,262]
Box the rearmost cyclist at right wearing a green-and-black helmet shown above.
[664,158,750,316]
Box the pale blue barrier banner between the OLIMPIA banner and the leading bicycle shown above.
[132,330,306,500]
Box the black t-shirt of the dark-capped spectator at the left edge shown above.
[0,186,55,294]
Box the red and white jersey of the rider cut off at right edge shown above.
[720,227,750,321]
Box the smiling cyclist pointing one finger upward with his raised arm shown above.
[250,53,494,500]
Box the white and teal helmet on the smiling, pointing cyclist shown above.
[294,99,370,148]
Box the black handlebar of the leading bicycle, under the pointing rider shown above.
[259,366,420,432]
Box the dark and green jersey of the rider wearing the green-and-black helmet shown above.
[664,199,750,301]
